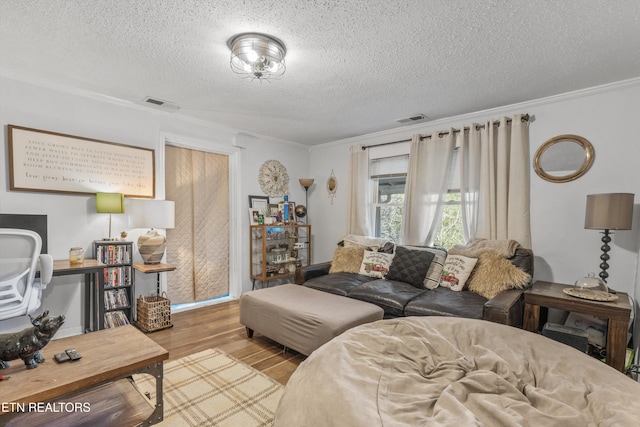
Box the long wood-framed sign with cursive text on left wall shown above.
[8,125,155,198]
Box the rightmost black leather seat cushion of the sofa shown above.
[404,287,487,319]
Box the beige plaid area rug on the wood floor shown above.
[133,349,284,427]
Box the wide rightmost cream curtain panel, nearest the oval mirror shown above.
[458,114,531,248]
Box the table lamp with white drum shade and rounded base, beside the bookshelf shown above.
[128,199,175,264]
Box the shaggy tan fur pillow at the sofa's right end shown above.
[467,251,531,299]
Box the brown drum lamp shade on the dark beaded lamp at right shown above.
[584,193,634,230]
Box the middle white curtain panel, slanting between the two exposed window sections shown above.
[400,129,455,245]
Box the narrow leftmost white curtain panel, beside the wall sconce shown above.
[347,145,372,236]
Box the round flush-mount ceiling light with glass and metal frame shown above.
[227,33,287,80]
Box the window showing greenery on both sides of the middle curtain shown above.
[369,150,465,248]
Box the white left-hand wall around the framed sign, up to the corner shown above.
[0,75,308,337]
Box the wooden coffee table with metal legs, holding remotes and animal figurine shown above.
[0,325,169,425]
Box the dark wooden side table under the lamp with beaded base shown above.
[524,281,631,372]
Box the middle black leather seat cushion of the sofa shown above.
[348,279,428,317]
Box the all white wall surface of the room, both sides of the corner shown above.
[0,72,640,360]
